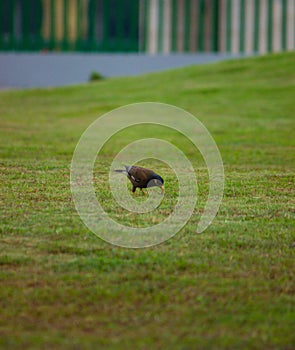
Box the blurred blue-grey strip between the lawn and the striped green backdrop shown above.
[0,53,243,89]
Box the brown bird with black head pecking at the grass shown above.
[114,165,164,195]
